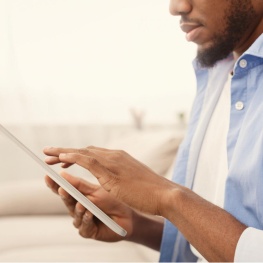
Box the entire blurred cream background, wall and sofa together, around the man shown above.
[0,0,195,262]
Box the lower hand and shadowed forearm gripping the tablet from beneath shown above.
[45,171,163,250]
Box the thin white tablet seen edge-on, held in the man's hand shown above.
[0,124,127,236]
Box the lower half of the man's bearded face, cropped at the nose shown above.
[170,0,256,67]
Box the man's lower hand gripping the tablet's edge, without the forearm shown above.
[45,171,135,242]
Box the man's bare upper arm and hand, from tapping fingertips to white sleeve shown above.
[44,147,249,262]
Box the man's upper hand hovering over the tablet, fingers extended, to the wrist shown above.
[44,147,174,215]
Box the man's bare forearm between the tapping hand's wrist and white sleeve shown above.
[161,186,249,262]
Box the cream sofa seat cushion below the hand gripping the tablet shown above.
[0,215,159,262]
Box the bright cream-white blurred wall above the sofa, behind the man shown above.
[0,0,195,126]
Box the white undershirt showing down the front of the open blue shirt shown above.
[191,74,231,261]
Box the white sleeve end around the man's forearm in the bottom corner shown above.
[234,227,263,262]
